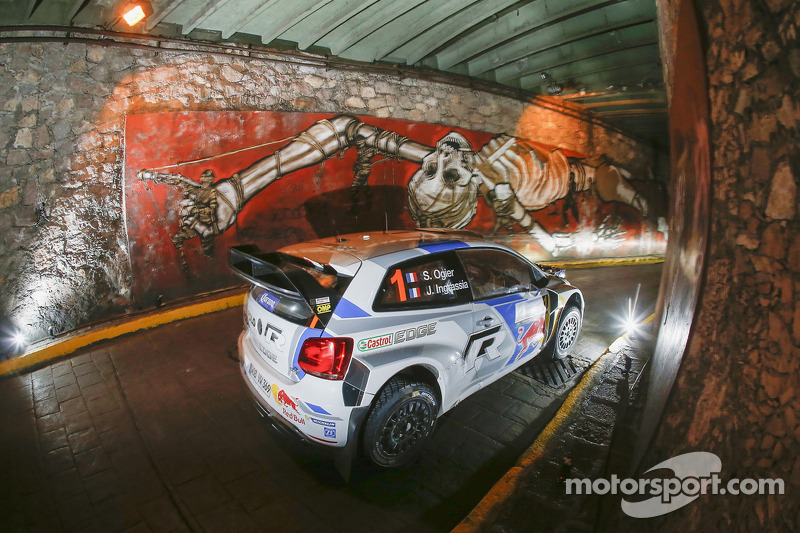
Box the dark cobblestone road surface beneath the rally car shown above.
[0,264,664,532]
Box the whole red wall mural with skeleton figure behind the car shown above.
[125,111,665,306]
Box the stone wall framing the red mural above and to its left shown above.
[0,43,653,350]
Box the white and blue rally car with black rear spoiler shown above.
[230,230,584,467]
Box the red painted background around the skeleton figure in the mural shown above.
[124,111,664,306]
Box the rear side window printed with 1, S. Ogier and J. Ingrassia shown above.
[373,252,471,311]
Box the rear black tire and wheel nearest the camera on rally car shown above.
[363,376,439,468]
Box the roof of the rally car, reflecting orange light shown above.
[279,229,500,273]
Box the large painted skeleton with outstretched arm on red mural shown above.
[138,115,647,256]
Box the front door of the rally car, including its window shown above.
[458,248,546,385]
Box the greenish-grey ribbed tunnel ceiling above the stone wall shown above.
[0,0,667,145]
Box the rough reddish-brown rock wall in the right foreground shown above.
[644,0,800,531]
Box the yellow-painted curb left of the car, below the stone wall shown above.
[0,291,247,378]
